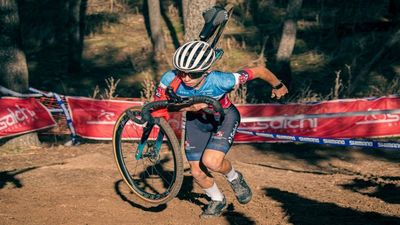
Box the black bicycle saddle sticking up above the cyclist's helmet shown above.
[199,6,233,49]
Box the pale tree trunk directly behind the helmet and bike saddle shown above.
[182,0,216,42]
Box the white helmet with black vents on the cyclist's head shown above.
[172,41,216,73]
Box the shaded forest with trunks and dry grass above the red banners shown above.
[0,0,400,146]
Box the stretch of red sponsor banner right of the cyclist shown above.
[235,97,400,142]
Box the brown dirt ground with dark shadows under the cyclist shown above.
[0,143,400,225]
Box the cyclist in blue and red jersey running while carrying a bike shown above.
[152,41,288,218]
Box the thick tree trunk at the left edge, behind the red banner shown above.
[0,0,40,148]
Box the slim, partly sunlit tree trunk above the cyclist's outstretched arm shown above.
[276,0,303,86]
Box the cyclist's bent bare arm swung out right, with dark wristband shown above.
[244,66,288,99]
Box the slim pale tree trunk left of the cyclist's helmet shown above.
[147,0,165,54]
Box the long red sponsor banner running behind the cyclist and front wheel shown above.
[67,97,400,142]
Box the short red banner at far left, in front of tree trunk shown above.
[0,97,56,139]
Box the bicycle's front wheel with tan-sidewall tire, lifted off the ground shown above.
[113,107,183,205]
